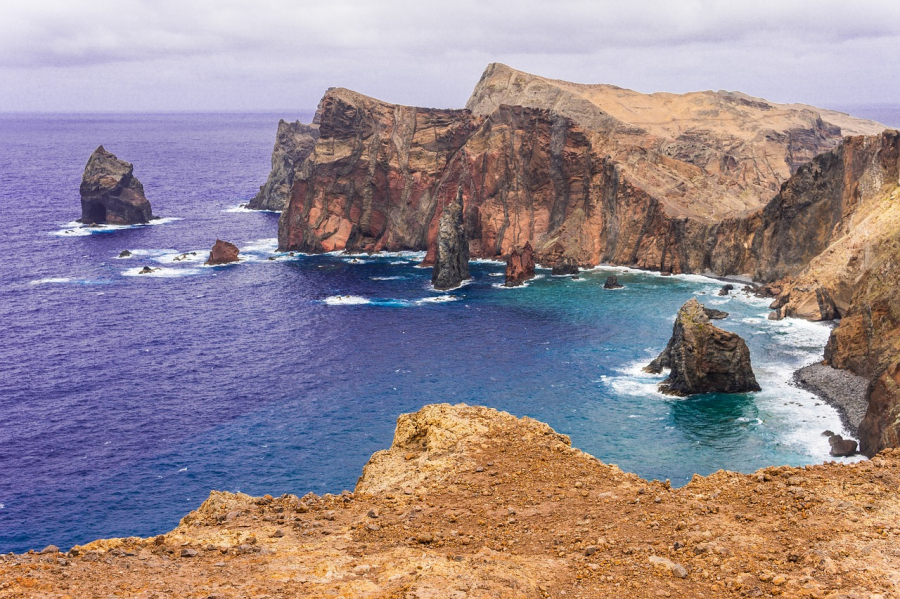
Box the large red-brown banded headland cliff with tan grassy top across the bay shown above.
[279,65,881,272]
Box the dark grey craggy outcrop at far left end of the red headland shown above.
[247,119,319,210]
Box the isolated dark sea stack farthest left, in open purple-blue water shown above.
[80,146,154,225]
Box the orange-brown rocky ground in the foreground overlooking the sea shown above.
[0,404,900,598]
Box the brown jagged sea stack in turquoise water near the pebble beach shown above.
[644,298,760,395]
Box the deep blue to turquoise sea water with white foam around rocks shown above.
[0,114,864,552]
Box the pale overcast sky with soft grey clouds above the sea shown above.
[0,0,900,116]
